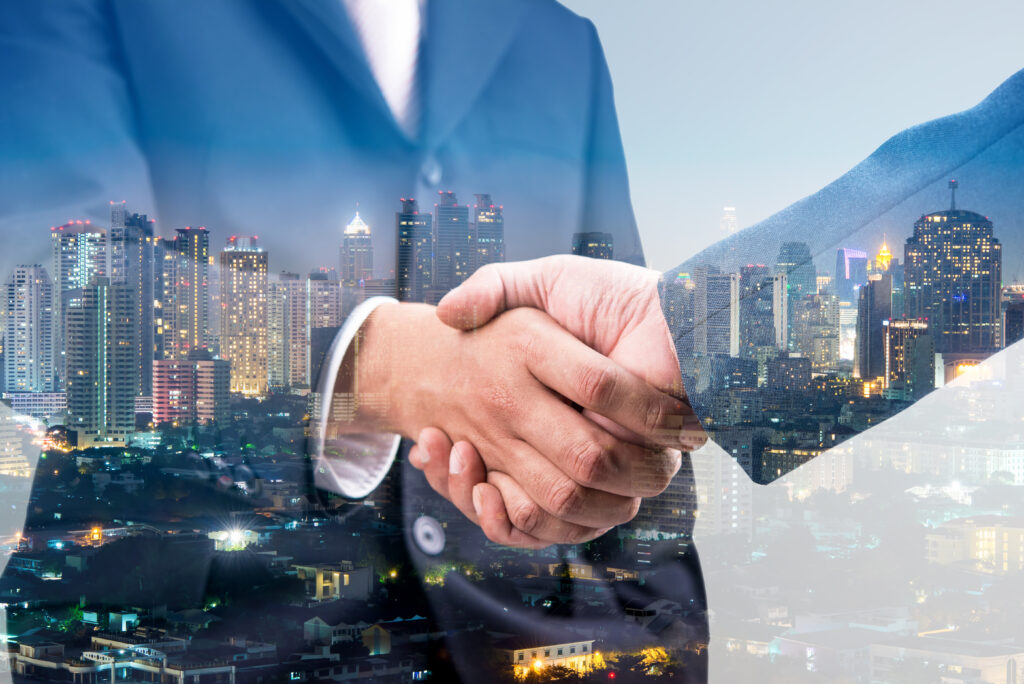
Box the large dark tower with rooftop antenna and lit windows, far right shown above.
[903,183,1002,353]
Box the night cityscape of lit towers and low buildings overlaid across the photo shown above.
[0,181,1024,684]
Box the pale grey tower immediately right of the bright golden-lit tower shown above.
[267,272,309,389]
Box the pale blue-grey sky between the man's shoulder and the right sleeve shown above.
[564,0,1024,270]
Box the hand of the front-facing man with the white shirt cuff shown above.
[339,304,687,547]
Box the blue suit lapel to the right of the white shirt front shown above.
[420,0,530,147]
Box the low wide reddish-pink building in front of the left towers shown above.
[153,351,230,425]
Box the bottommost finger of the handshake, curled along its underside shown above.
[481,471,606,544]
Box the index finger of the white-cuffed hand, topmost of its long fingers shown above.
[525,327,693,448]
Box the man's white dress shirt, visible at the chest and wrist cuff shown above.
[312,0,424,500]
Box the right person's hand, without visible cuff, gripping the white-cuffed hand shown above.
[410,256,707,543]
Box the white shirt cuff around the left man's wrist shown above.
[311,297,401,500]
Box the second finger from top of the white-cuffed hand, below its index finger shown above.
[520,389,682,497]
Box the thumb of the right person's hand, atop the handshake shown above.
[437,262,544,330]
